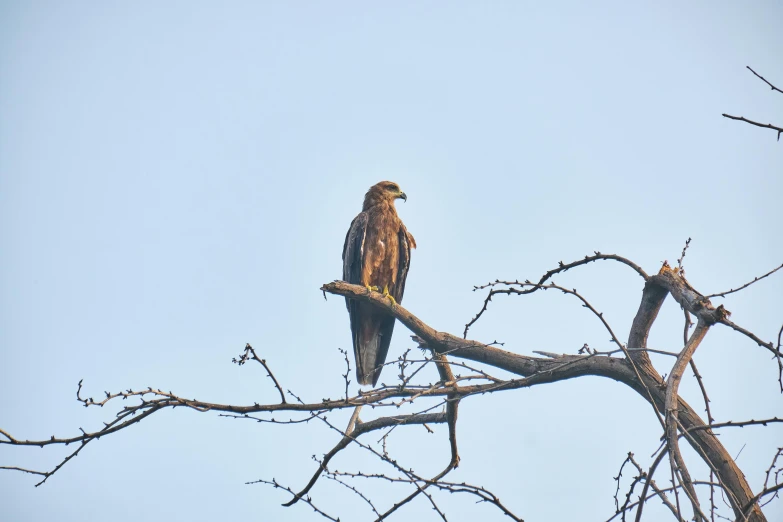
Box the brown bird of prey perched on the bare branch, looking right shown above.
[343,181,416,386]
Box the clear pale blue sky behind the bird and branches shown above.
[0,0,783,522]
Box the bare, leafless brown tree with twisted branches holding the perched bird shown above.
[0,249,783,522]
